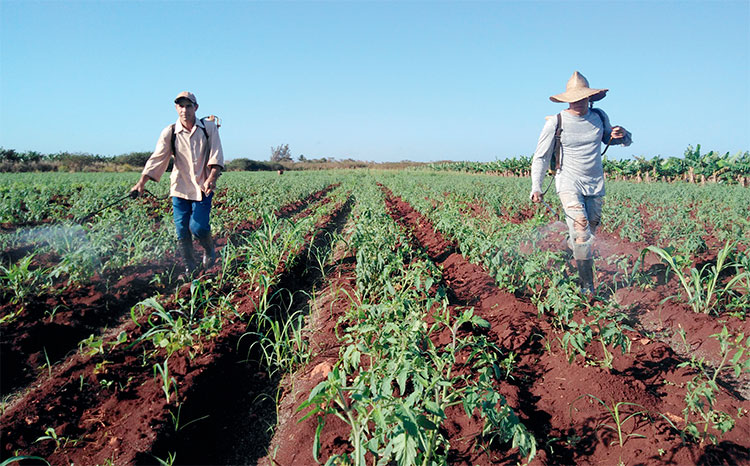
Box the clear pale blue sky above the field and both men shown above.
[0,0,750,162]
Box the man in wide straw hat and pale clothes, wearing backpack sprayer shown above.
[531,71,632,294]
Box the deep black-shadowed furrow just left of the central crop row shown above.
[145,194,353,465]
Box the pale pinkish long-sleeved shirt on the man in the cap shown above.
[143,118,224,201]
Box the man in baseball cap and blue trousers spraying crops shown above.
[131,91,224,277]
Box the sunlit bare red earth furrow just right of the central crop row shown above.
[376,189,750,464]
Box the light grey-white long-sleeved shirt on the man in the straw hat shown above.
[531,110,633,196]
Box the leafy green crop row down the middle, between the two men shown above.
[274,180,535,465]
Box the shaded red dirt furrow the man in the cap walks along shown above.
[0,185,337,396]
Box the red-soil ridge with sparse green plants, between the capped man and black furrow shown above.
[2,176,350,463]
